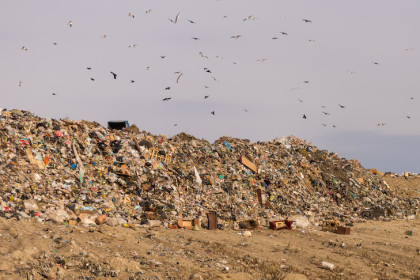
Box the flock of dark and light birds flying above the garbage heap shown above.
[18,9,414,128]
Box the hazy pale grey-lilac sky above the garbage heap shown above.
[0,0,420,173]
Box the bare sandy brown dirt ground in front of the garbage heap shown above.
[0,215,420,279]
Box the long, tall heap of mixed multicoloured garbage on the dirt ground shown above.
[0,109,420,229]
